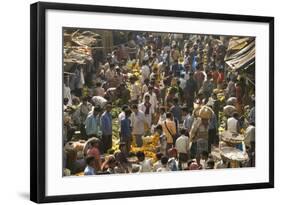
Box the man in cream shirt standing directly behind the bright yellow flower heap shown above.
[131,104,146,147]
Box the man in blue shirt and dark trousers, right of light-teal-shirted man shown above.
[101,103,112,153]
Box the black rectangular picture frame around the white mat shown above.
[30,2,274,203]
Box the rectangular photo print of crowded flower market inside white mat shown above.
[61,27,255,177]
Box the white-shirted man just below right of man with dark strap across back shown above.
[175,129,189,170]
